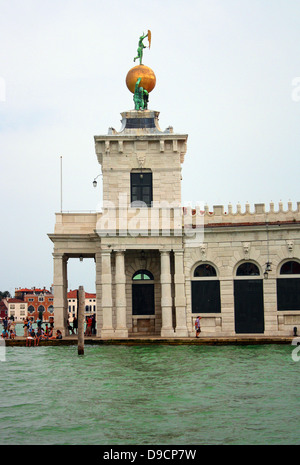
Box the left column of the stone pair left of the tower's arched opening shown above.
[101,250,114,338]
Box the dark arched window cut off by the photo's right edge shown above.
[277,260,300,310]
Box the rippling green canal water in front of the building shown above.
[0,345,300,445]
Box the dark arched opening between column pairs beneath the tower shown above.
[132,270,155,315]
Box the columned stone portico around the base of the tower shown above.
[49,219,188,338]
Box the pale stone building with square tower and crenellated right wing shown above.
[49,110,300,338]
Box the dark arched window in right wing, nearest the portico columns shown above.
[191,263,221,314]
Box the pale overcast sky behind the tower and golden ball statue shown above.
[0,0,300,294]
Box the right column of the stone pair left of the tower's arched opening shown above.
[115,250,128,337]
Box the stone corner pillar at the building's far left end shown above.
[53,253,68,336]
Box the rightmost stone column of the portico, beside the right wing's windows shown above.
[174,250,188,337]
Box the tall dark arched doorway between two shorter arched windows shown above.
[234,262,265,334]
